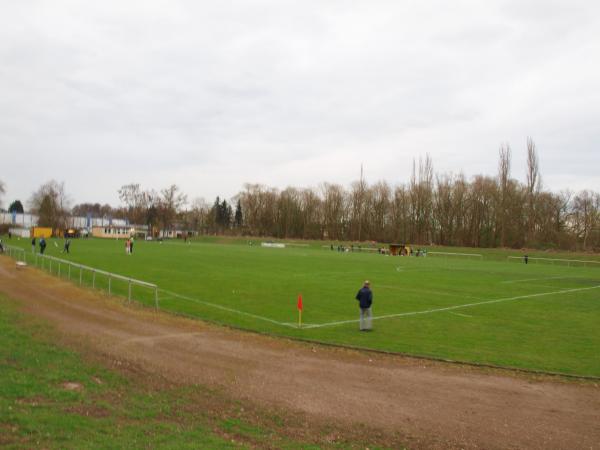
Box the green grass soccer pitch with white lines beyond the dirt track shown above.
[5,239,600,376]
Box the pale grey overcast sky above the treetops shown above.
[0,0,600,208]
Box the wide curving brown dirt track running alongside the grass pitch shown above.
[0,257,600,449]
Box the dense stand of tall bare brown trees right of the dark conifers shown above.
[220,144,600,249]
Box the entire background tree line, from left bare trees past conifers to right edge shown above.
[0,139,600,251]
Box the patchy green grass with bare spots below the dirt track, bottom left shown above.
[0,295,398,449]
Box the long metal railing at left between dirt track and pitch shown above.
[4,245,159,309]
